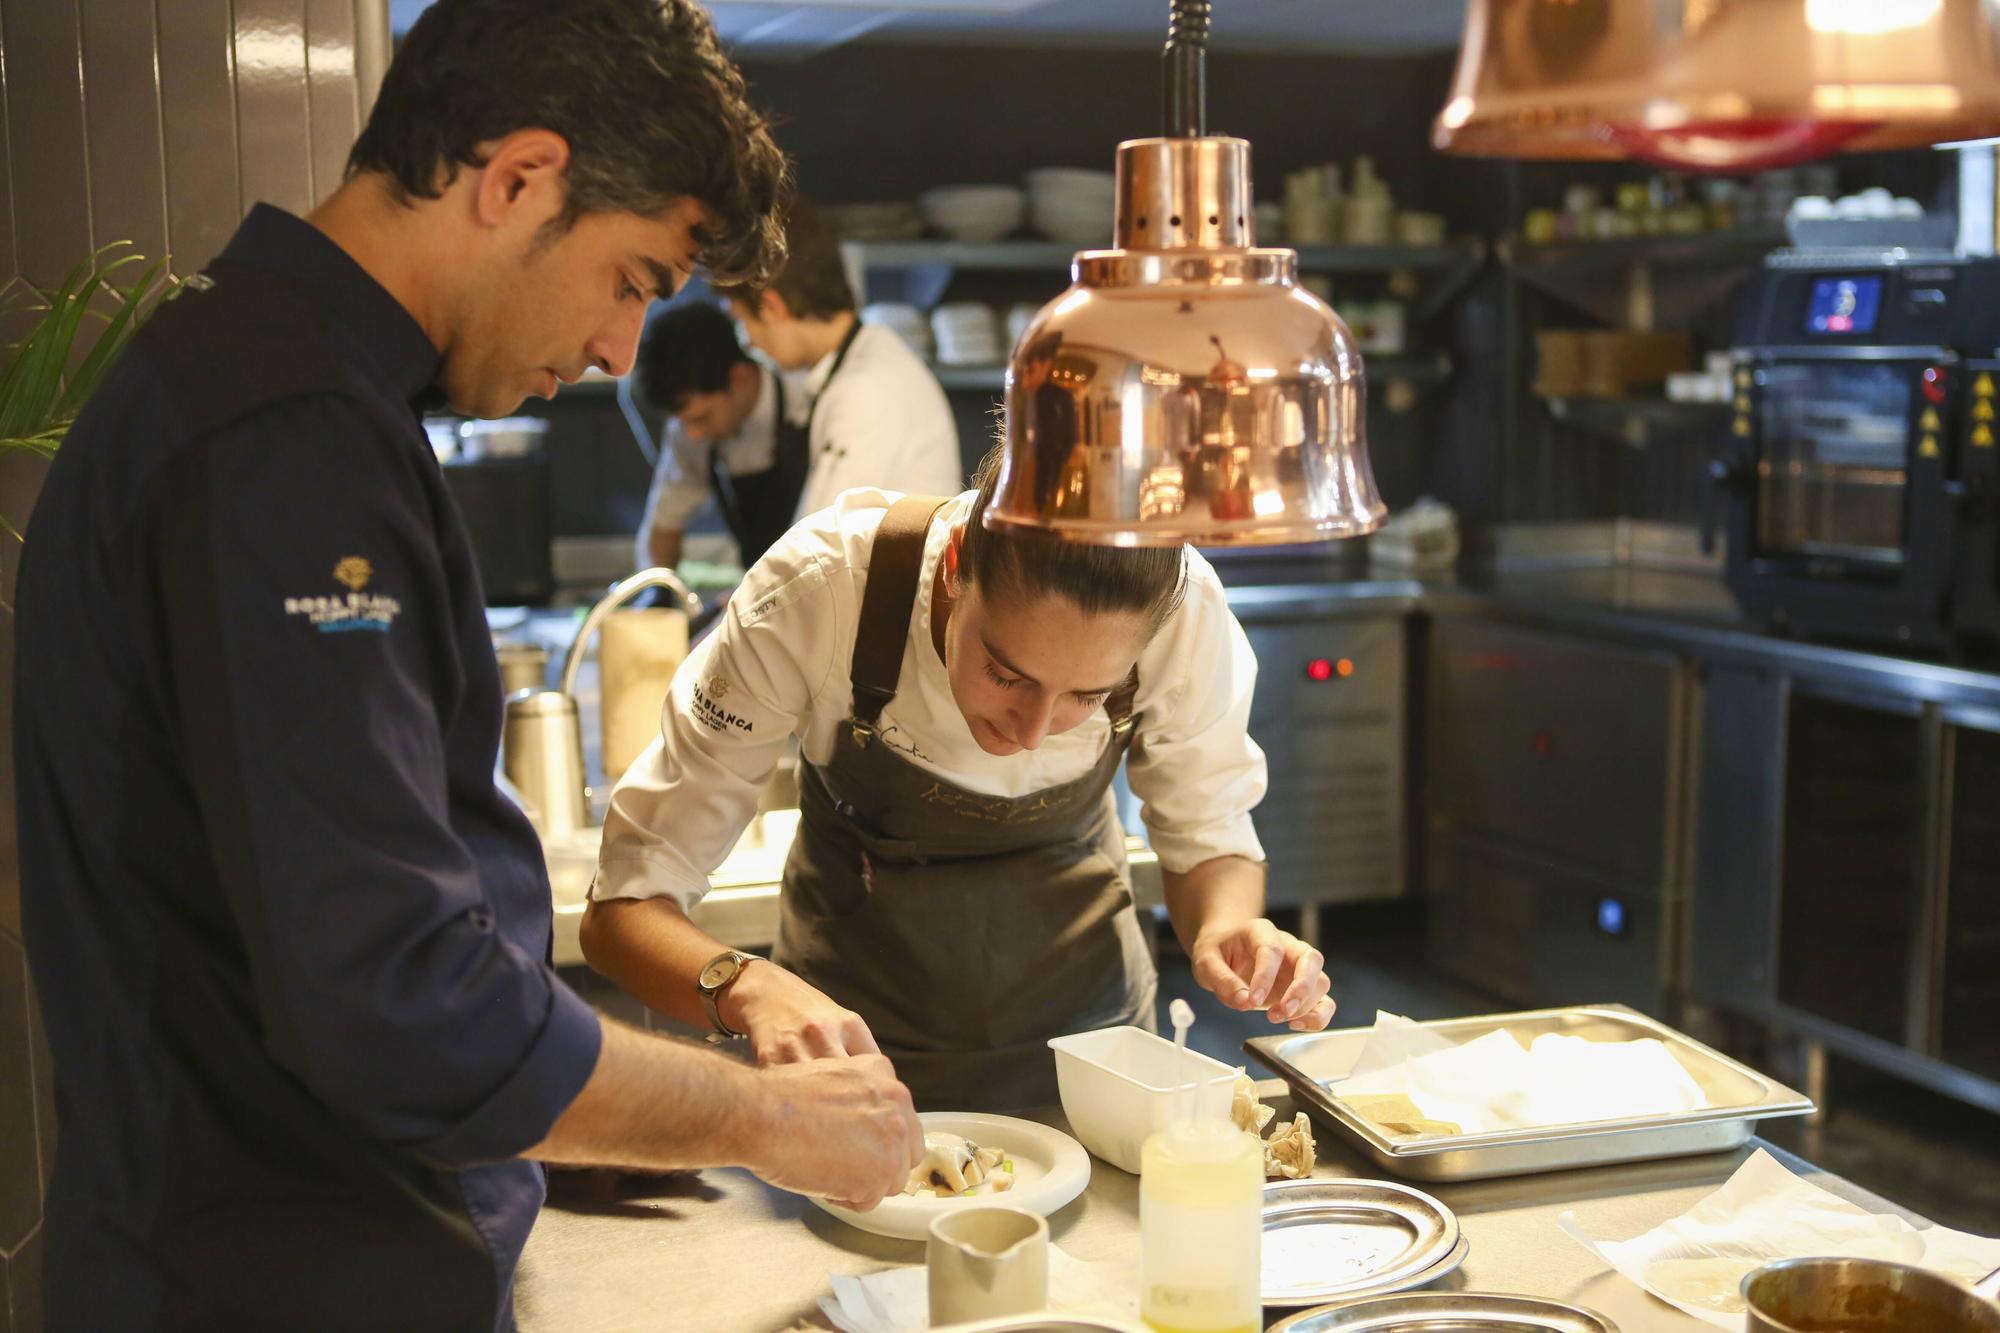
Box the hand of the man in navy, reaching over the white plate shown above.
[748,1048,924,1211]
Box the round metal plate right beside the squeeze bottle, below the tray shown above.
[1262,1179,1464,1307]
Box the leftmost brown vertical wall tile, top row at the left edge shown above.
[6,0,90,282]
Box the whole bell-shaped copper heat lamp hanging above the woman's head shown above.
[984,0,1386,546]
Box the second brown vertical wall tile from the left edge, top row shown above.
[82,0,166,260]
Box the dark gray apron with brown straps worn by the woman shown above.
[772,496,1158,1111]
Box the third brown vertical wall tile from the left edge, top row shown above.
[157,0,244,272]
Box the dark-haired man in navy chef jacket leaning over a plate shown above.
[14,0,922,1331]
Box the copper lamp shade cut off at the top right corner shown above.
[1432,0,2000,172]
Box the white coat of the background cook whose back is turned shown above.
[792,324,966,520]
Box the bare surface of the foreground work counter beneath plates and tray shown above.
[514,1081,1922,1333]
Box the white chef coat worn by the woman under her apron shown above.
[590,490,1266,907]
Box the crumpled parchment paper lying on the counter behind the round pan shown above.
[1560,1149,2000,1329]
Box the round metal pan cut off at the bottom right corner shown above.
[1742,1259,2000,1333]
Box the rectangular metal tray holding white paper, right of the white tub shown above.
[1244,1005,1814,1181]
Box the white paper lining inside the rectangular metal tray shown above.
[1328,1013,1708,1137]
